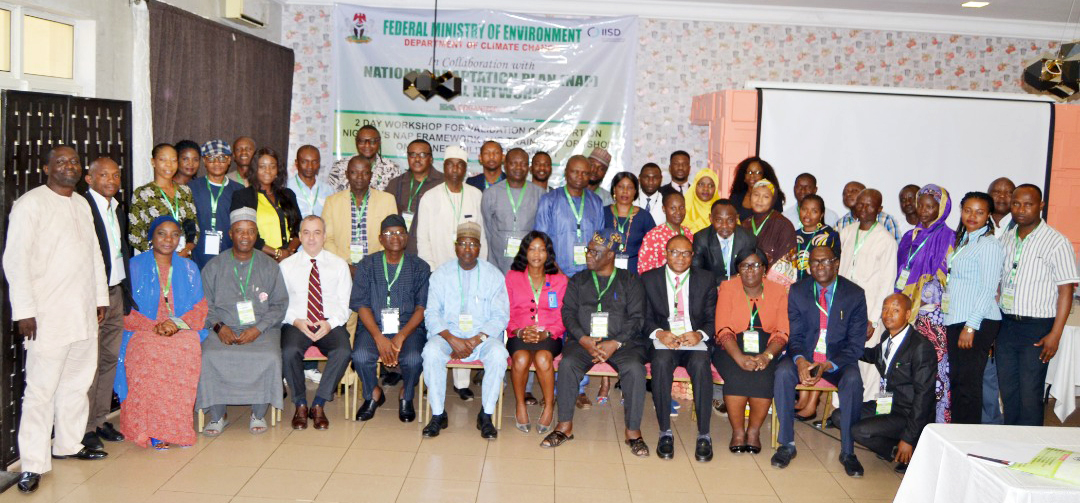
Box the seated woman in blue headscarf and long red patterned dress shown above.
[113,215,207,449]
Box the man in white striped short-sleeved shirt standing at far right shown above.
[997,183,1080,426]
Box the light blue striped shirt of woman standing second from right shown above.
[945,227,1005,330]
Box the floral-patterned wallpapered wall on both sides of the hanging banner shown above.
[282,5,1057,168]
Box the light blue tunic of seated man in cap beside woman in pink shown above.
[423,259,510,339]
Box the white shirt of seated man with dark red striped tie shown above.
[281,247,352,328]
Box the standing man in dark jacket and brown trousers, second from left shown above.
[82,158,132,450]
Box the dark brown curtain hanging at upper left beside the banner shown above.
[147,1,295,157]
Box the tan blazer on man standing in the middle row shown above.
[322,189,397,262]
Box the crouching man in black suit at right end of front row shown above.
[851,294,937,473]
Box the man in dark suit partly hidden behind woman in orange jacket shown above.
[693,199,757,285]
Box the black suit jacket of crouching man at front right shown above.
[861,325,937,446]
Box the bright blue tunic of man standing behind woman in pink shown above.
[536,188,604,276]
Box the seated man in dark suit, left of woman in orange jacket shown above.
[642,235,716,462]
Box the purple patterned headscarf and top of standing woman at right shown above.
[896,183,956,321]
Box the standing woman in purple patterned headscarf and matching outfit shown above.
[895,183,956,423]
